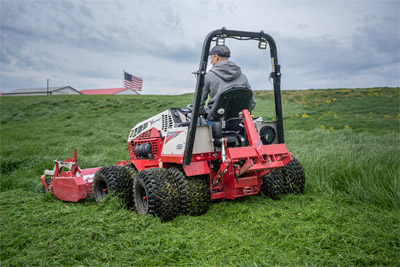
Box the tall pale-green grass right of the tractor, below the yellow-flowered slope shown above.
[287,129,400,208]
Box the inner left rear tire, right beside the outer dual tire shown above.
[168,166,210,216]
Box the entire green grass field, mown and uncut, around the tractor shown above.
[0,88,400,266]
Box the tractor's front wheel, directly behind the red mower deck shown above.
[93,166,133,205]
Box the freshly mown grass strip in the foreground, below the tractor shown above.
[1,190,400,266]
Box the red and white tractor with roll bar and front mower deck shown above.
[41,28,305,220]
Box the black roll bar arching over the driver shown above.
[183,28,285,165]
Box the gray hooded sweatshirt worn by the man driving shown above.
[199,60,256,114]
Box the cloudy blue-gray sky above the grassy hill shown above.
[0,0,400,94]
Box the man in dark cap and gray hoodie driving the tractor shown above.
[199,45,256,119]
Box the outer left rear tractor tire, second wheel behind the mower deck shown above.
[133,168,179,221]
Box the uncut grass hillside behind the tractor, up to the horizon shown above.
[0,88,400,208]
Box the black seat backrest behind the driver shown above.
[208,87,253,121]
